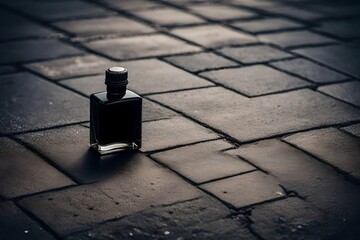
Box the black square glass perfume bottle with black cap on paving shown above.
[90,67,142,154]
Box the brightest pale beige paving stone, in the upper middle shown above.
[171,25,257,48]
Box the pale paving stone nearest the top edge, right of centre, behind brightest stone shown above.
[187,4,256,21]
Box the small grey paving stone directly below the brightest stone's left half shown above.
[165,52,239,72]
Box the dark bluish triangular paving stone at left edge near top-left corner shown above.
[0,9,55,40]
